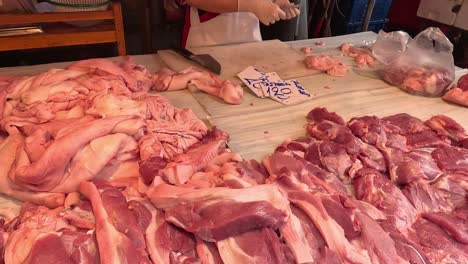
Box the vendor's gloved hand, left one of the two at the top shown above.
[237,0,287,26]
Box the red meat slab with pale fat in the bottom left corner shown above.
[5,203,99,263]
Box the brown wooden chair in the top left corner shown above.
[0,2,126,56]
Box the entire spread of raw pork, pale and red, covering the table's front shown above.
[0,60,468,264]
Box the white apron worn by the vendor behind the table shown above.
[185,7,262,48]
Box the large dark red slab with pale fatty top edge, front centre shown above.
[148,184,290,241]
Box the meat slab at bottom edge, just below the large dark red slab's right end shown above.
[216,228,288,264]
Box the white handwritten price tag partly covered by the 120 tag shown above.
[237,66,282,98]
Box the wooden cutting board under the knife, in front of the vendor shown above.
[158,40,319,80]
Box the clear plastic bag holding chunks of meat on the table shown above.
[373,28,455,97]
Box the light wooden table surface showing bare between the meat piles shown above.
[0,32,468,160]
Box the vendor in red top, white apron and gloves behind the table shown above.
[165,0,300,48]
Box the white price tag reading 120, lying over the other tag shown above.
[261,80,312,105]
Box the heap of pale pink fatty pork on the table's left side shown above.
[0,59,245,207]
